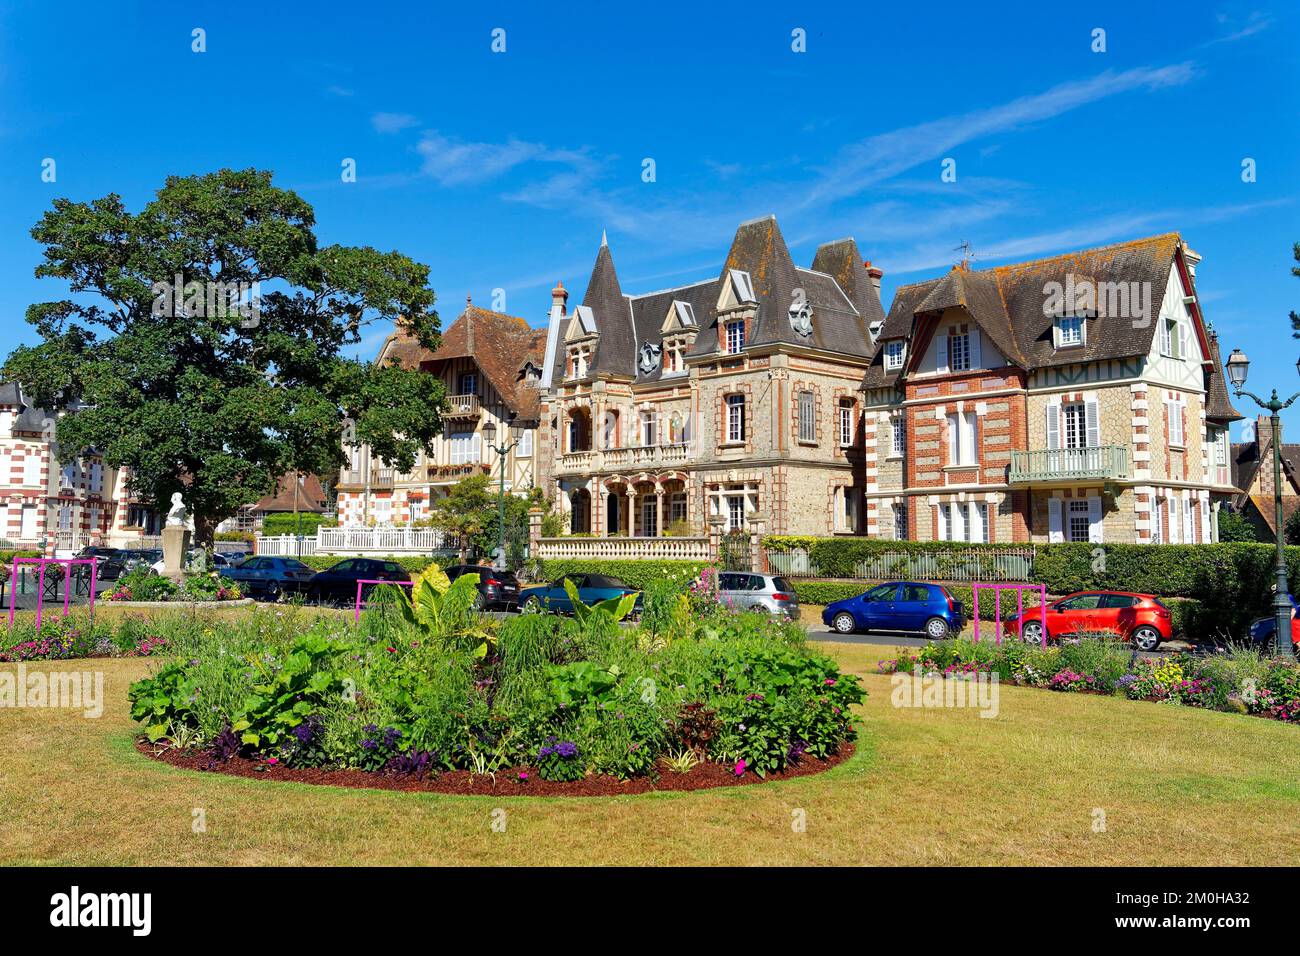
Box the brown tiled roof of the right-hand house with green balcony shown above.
[863,233,1240,420]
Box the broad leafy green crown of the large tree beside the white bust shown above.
[4,169,445,544]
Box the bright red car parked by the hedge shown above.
[1006,591,1174,650]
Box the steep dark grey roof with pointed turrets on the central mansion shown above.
[569,216,884,382]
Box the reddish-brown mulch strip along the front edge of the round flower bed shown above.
[135,739,854,796]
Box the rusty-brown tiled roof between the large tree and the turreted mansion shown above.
[380,300,546,421]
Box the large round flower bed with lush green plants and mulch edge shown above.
[130,568,866,793]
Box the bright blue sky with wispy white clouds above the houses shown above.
[0,0,1300,437]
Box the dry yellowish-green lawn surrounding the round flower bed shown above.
[0,644,1300,865]
